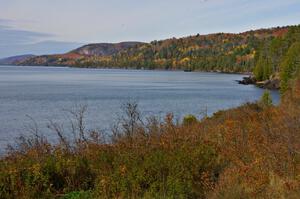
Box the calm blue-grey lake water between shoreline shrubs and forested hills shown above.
[0,66,279,151]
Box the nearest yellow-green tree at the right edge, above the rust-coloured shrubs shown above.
[280,42,300,93]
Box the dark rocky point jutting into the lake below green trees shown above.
[237,76,280,90]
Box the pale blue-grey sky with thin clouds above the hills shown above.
[0,0,300,57]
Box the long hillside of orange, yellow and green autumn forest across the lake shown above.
[17,27,291,72]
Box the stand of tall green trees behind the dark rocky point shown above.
[253,26,300,91]
